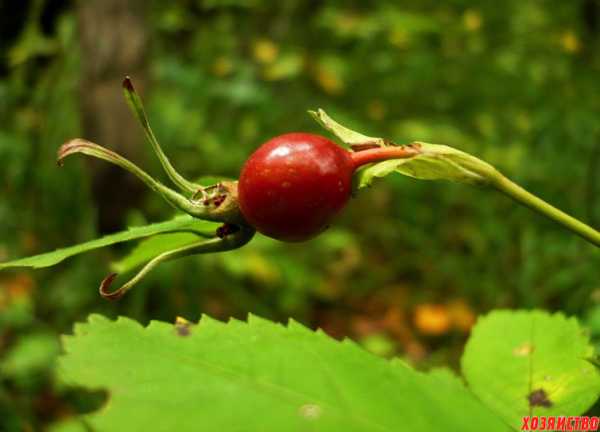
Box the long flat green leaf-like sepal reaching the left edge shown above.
[0,216,219,270]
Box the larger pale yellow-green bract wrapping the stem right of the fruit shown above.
[358,142,496,189]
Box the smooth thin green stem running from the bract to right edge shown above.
[490,173,600,247]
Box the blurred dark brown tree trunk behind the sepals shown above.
[78,0,148,233]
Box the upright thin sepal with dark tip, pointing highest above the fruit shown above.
[123,76,202,193]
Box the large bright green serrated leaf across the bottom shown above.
[59,315,507,432]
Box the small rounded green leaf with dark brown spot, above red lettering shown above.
[462,311,600,428]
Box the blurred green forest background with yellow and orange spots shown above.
[0,0,600,431]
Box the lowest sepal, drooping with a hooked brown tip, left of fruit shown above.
[99,224,255,300]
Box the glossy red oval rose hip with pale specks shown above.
[238,133,354,242]
